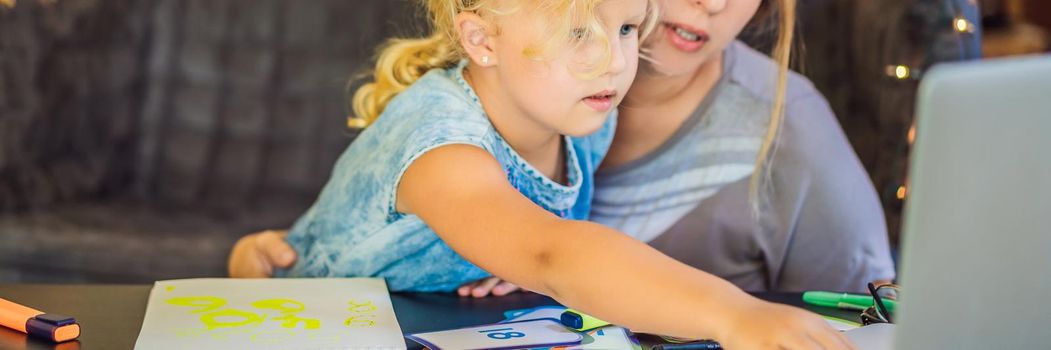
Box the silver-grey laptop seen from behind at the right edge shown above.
[852,56,1051,350]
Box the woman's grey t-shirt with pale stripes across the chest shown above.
[592,42,894,291]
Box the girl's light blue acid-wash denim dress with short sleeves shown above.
[279,61,616,291]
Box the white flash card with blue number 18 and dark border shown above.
[407,318,583,350]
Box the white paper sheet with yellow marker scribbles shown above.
[136,279,406,350]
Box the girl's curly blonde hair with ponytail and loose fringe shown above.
[347,0,657,128]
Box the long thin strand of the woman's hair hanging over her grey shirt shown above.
[748,0,796,212]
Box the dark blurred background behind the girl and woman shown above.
[0,0,980,282]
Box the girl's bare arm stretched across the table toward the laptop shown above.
[396,145,850,349]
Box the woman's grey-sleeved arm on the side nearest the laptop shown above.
[772,91,894,291]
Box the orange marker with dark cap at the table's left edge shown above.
[0,298,80,343]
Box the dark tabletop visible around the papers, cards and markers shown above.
[0,284,858,350]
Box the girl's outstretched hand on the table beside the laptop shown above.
[717,300,854,350]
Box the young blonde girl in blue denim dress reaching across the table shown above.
[254,0,850,349]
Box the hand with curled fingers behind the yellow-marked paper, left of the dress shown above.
[227,230,295,279]
